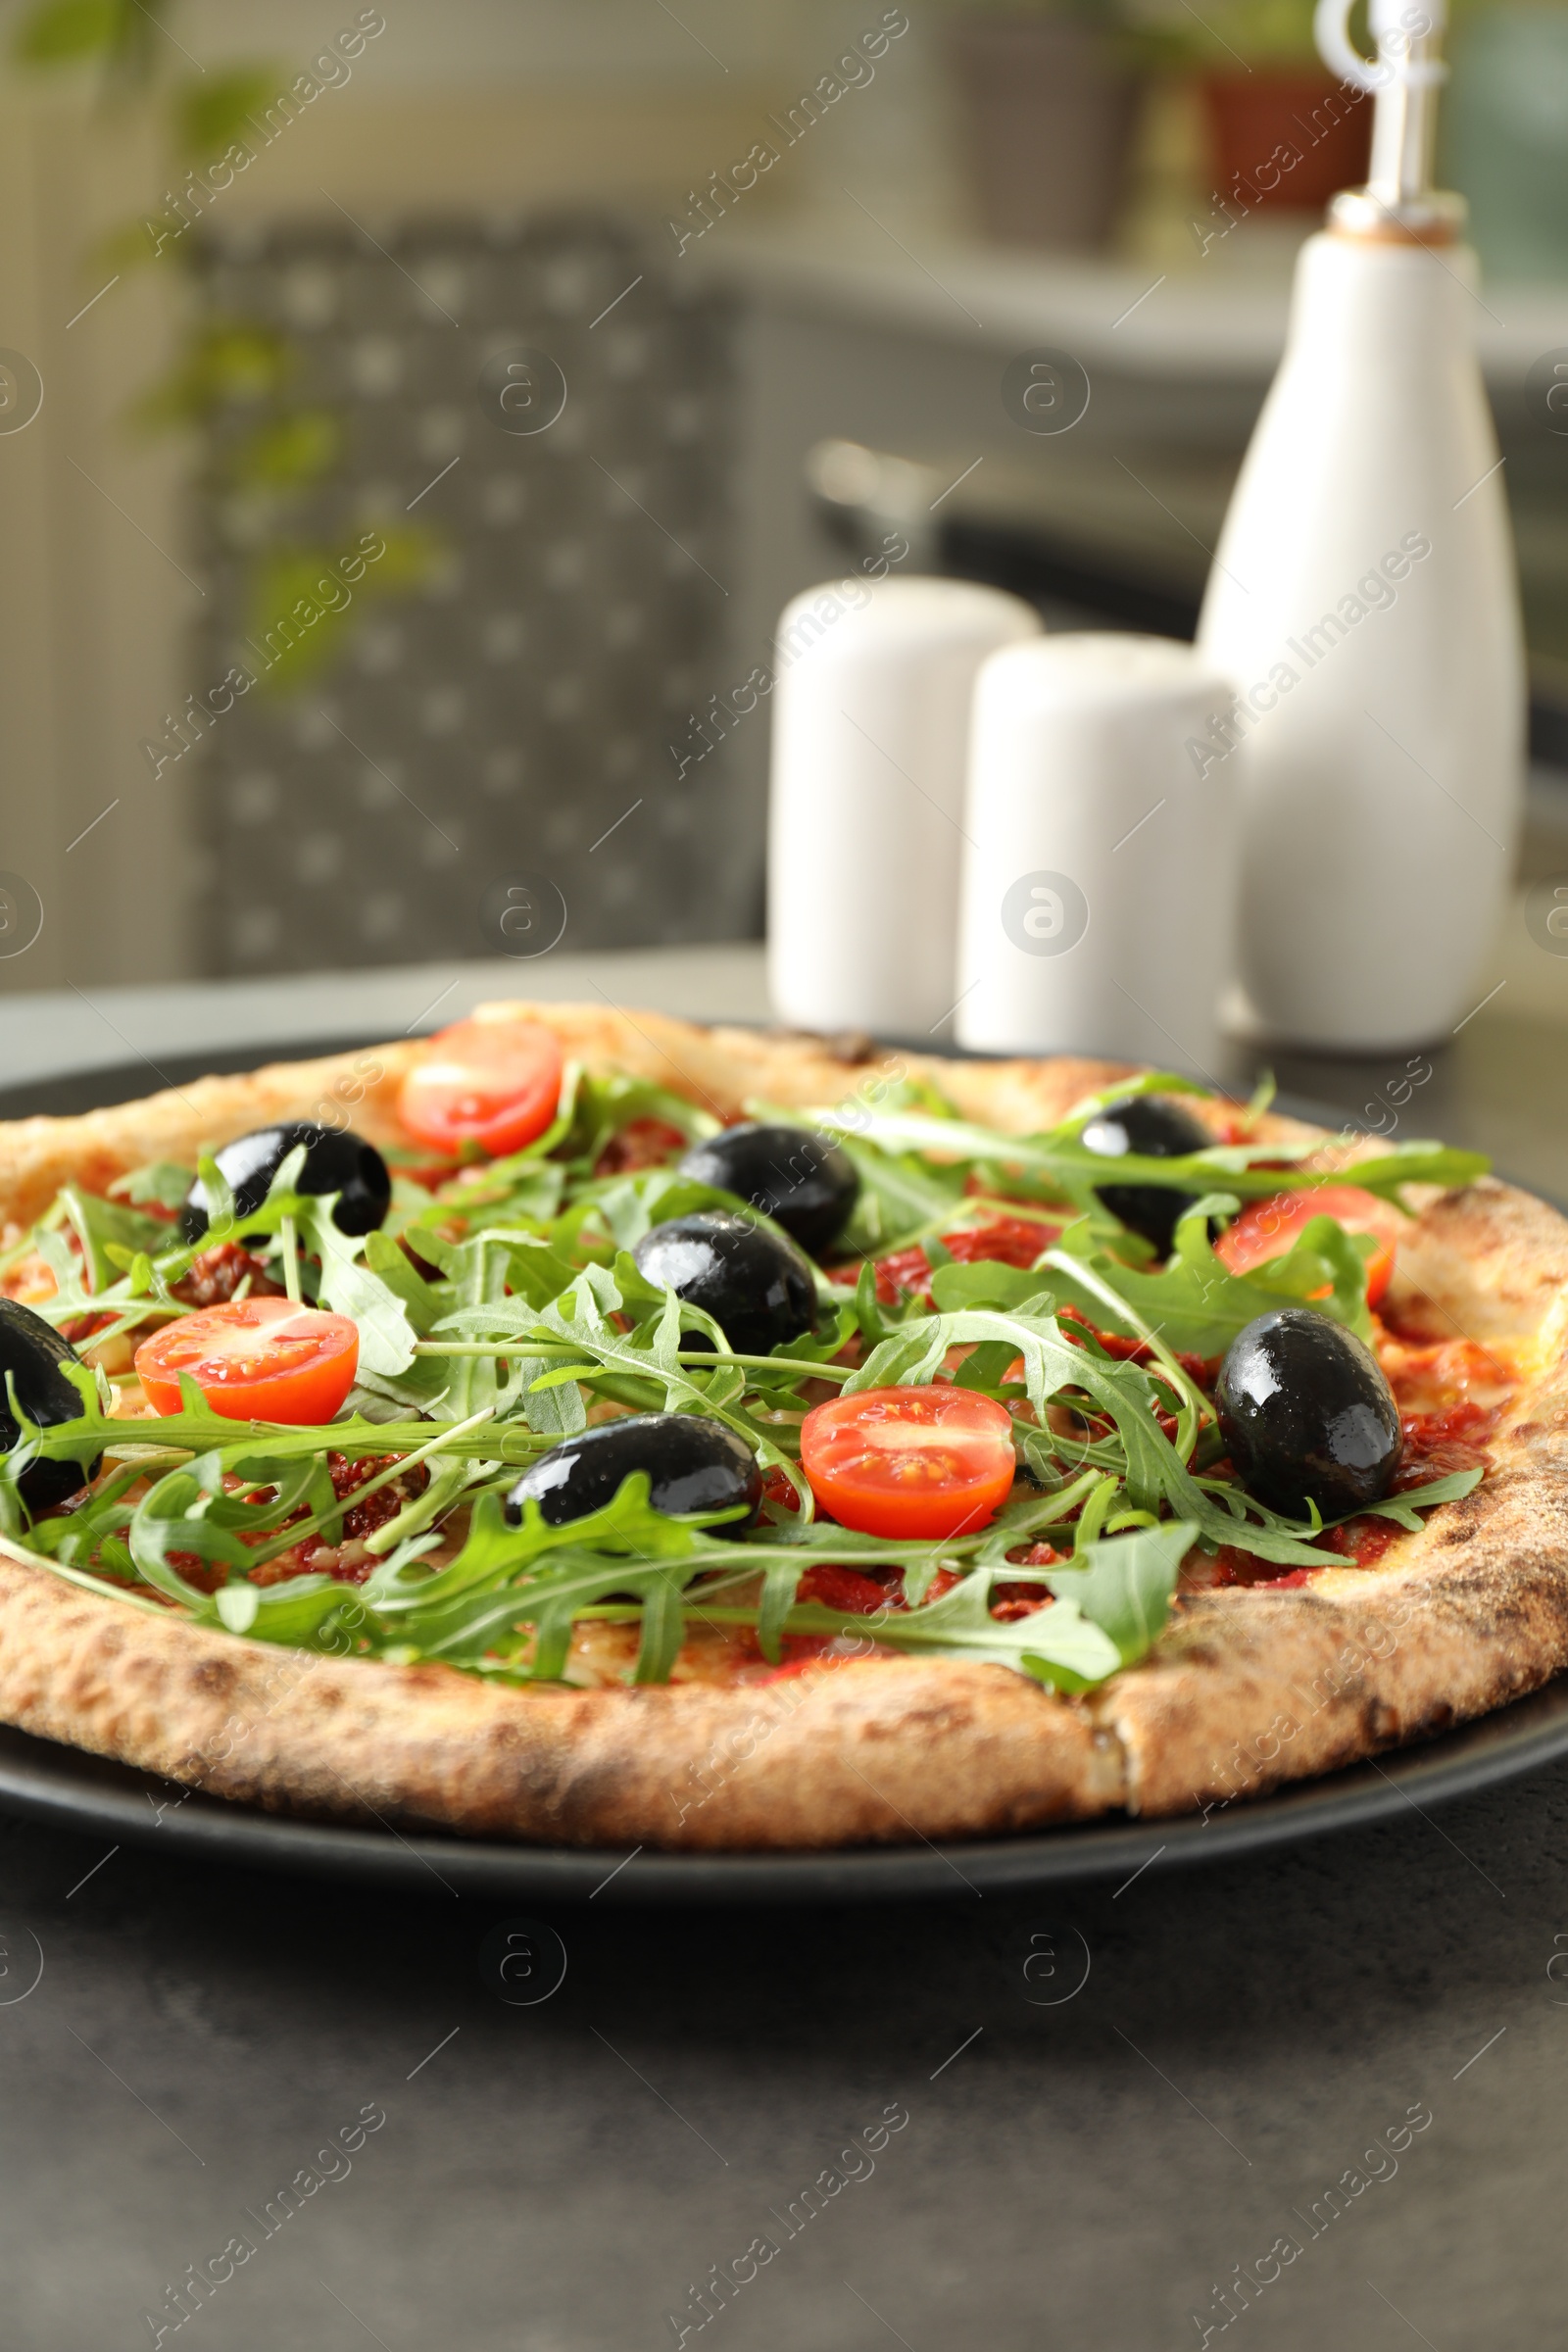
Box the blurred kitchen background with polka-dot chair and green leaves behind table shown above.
[0,0,1568,990]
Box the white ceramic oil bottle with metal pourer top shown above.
[1190,0,1526,1052]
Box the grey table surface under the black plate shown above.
[0,951,1568,2352]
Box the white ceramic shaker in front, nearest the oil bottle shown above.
[955,635,1237,1075]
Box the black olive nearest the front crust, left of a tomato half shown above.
[506,1413,761,1536]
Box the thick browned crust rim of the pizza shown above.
[0,1004,1568,1848]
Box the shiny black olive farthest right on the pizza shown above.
[1215,1307,1401,1519]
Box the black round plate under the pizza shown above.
[0,1037,1568,1905]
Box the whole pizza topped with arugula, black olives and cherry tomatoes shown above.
[0,1004,1568,1848]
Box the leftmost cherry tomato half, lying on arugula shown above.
[136,1298,360,1423]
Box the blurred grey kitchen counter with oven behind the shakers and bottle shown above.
[700,214,1568,837]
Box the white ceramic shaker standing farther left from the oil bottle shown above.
[768,578,1039,1037]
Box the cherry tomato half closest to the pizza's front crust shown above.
[800,1388,1013,1536]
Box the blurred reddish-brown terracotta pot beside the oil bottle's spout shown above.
[1203,69,1373,212]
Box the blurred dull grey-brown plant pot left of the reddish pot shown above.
[948,17,1138,252]
